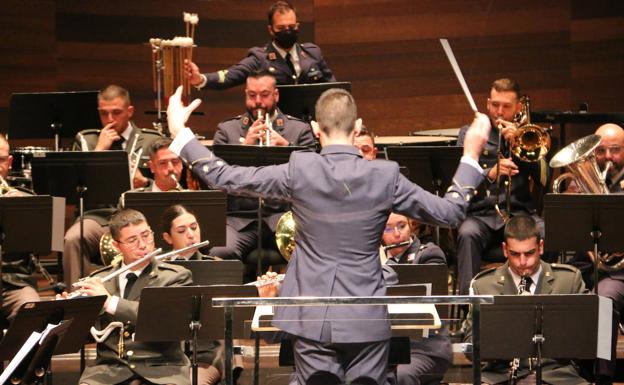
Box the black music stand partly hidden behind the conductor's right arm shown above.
[386,146,463,245]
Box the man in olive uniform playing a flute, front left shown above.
[64,209,192,385]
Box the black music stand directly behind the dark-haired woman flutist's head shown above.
[120,190,227,249]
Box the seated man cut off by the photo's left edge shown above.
[0,134,39,325]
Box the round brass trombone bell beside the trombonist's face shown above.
[510,96,551,162]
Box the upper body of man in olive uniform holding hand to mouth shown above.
[72,84,161,188]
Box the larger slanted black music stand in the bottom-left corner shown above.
[0,296,106,377]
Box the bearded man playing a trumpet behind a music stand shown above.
[211,71,314,268]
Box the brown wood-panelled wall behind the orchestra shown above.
[0,0,624,146]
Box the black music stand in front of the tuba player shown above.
[544,194,624,294]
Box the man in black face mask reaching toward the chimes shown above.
[185,1,336,89]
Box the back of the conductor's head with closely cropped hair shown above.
[316,88,357,135]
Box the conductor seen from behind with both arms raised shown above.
[167,87,490,385]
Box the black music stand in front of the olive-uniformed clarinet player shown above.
[480,294,612,384]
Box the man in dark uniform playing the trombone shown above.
[457,79,548,295]
